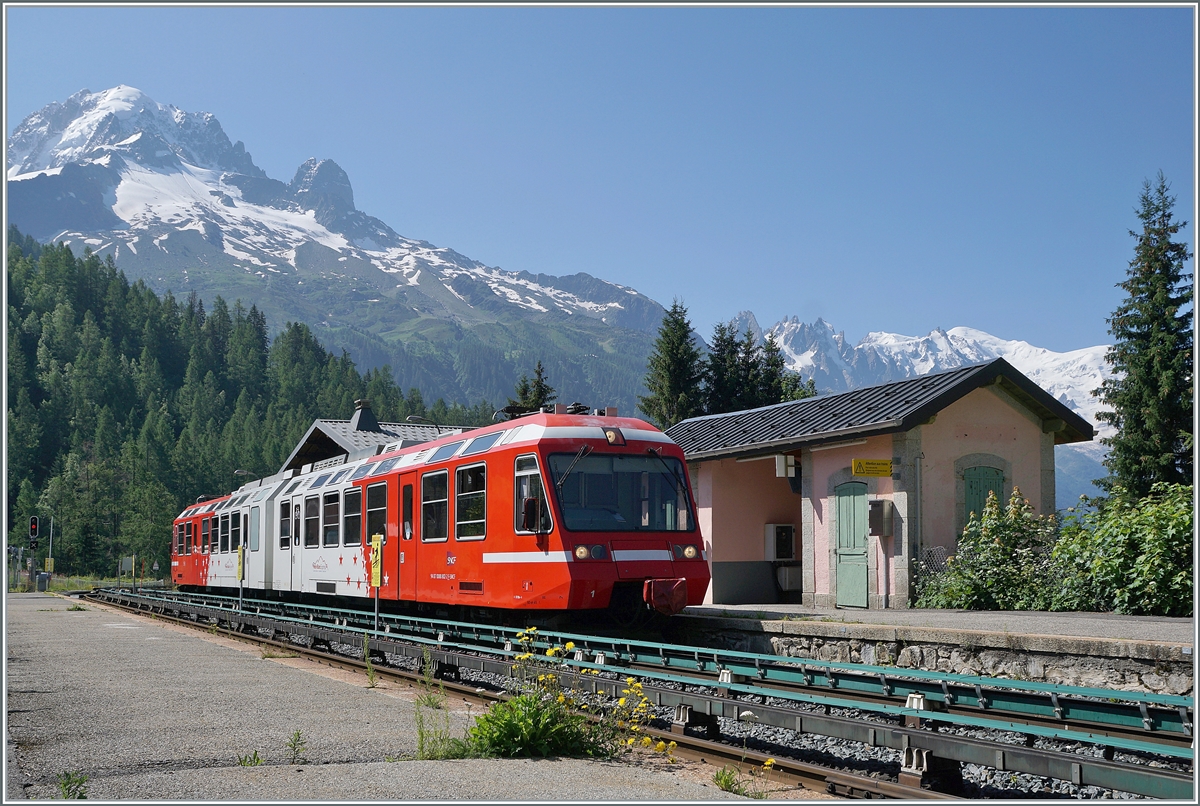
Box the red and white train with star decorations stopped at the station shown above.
[172,413,710,622]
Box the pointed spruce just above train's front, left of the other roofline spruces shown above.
[637,300,703,429]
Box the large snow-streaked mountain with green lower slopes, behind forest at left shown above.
[6,86,662,409]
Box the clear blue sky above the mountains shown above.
[5,6,1196,350]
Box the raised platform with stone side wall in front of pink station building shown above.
[671,605,1195,696]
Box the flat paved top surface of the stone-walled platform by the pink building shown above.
[684,605,1195,646]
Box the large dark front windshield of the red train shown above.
[550,452,696,531]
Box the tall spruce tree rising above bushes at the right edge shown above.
[1092,172,1194,497]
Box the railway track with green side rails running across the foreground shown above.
[84,590,1193,800]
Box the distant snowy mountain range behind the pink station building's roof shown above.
[734,311,1112,507]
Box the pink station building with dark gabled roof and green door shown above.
[667,359,1093,608]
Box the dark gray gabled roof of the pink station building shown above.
[666,359,1093,461]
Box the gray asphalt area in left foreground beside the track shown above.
[5,594,758,802]
